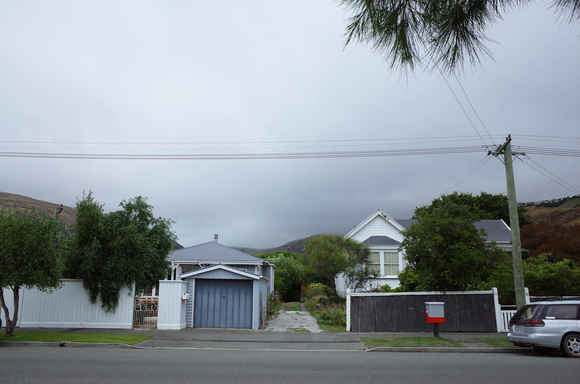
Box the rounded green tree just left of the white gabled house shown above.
[304,234,374,297]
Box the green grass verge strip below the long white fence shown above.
[0,333,151,345]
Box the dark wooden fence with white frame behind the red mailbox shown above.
[347,291,497,332]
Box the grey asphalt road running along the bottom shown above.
[0,346,580,384]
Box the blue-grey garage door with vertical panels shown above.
[193,279,253,329]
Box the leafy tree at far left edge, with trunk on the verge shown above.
[0,207,62,337]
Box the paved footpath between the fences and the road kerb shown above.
[0,328,533,353]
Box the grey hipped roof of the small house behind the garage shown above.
[169,241,264,264]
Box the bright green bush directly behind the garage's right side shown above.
[256,251,305,301]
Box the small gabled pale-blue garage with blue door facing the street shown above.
[181,264,268,329]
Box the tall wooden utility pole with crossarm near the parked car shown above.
[488,135,526,309]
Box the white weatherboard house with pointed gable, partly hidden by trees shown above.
[336,209,511,296]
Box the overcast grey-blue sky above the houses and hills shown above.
[0,0,580,248]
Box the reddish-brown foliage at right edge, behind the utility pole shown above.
[521,223,580,262]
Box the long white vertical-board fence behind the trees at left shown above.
[15,280,135,329]
